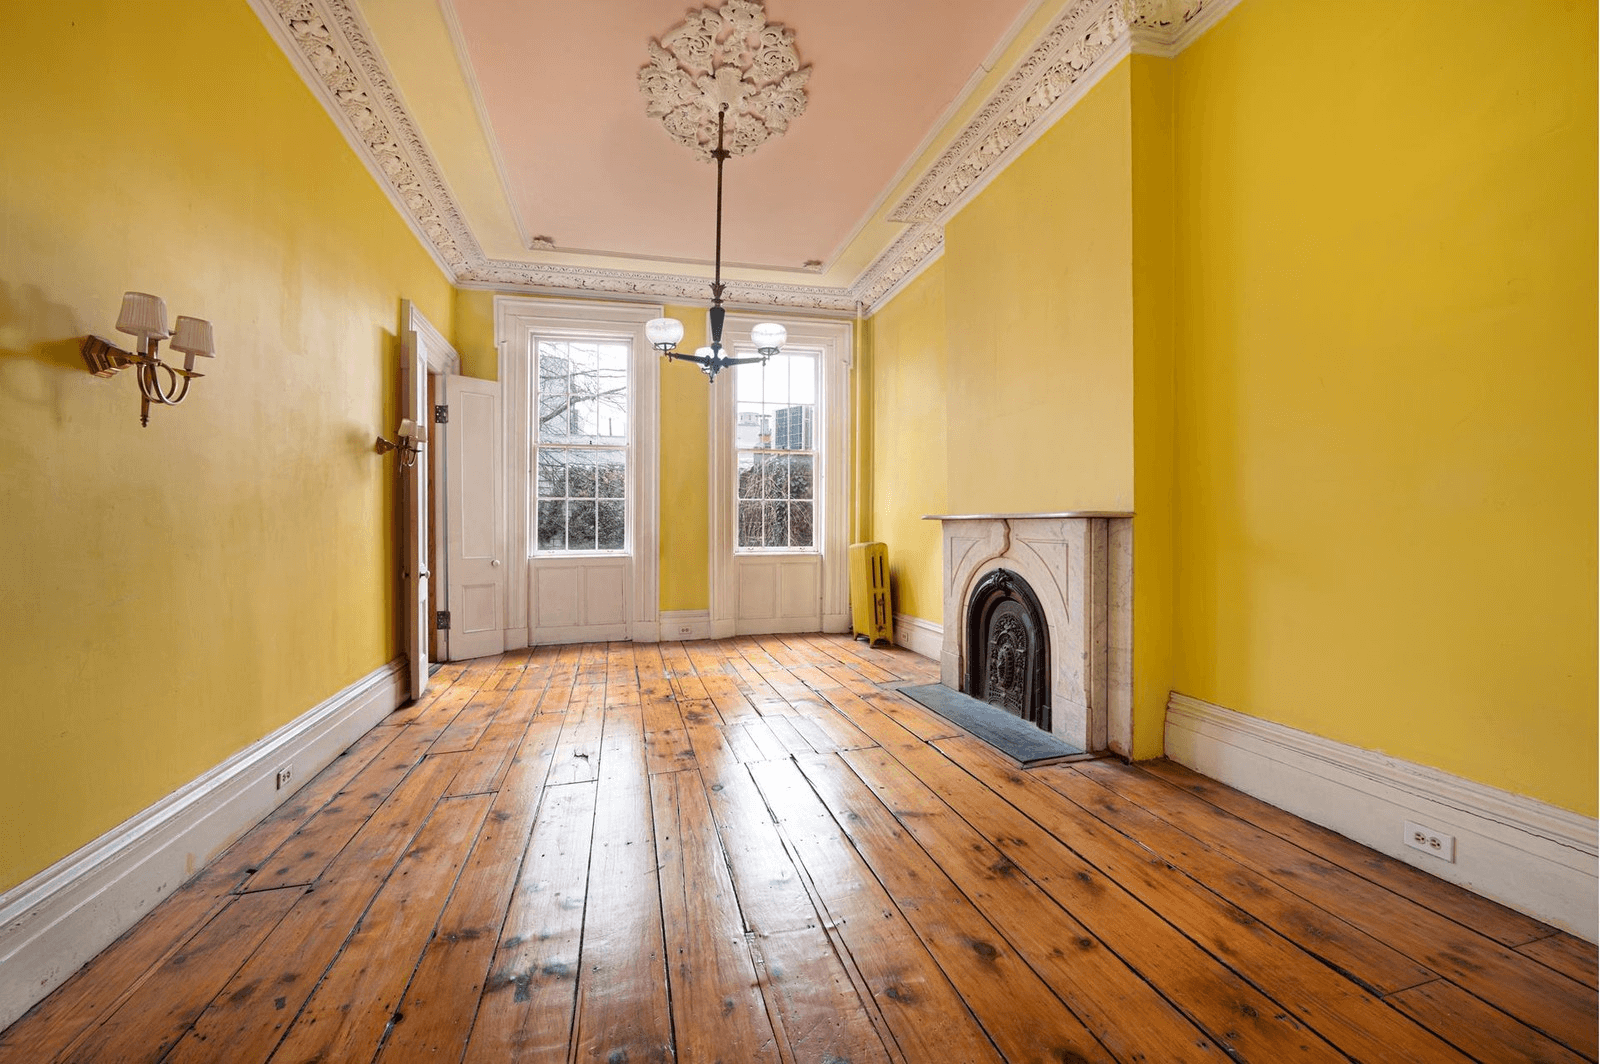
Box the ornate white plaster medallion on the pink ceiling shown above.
[638,0,811,162]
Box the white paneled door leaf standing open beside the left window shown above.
[435,374,506,661]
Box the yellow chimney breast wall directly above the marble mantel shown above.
[944,61,1133,514]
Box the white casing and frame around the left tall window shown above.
[494,296,662,646]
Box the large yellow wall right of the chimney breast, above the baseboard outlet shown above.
[1174,0,1597,814]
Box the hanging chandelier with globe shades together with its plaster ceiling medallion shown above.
[638,0,811,381]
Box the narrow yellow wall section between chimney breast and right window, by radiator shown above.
[867,261,949,624]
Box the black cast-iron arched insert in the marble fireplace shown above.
[962,570,1050,731]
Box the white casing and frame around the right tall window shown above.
[709,312,854,638]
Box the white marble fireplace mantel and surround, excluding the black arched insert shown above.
[923,510,1133,757]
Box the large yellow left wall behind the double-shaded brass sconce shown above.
[0,0,451,890]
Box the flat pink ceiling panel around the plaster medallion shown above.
[454,0,1027,269]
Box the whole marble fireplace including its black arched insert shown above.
[930,512,1133,757]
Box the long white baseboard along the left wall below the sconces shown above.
[0,658,410,1030]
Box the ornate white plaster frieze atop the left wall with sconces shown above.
[251,0,483,274]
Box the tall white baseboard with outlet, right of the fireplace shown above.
[1166,691,1600,942]
